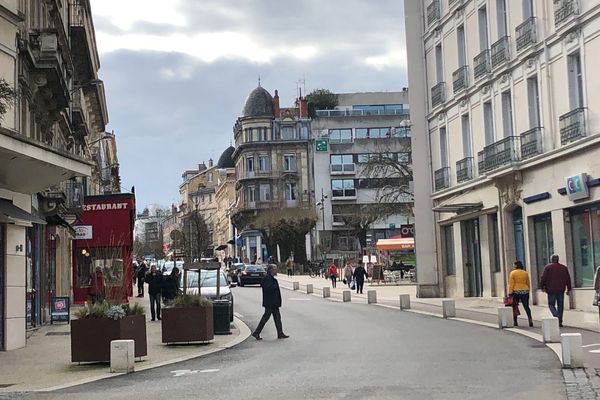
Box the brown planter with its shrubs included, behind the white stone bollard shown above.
[71,302,148,362]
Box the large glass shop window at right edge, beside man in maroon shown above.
[570,203,600,287]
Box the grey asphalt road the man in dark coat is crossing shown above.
[16,287,566,400]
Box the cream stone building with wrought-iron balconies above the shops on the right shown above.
[405,0,600,309]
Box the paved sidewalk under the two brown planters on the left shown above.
[0,296,250,393]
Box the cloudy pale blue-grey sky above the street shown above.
[92,0,408,208]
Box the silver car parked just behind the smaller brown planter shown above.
[177,265,233,321]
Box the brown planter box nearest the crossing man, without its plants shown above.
[161,306,214,343]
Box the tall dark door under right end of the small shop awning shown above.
[463,219,483,297]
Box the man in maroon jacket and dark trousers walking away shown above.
[540,254,571,326]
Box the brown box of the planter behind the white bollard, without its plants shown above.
[71,315,148,362]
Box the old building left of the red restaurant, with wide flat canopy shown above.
[0,0,108,350]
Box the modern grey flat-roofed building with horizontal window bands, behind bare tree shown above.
[312,89,413,260]
